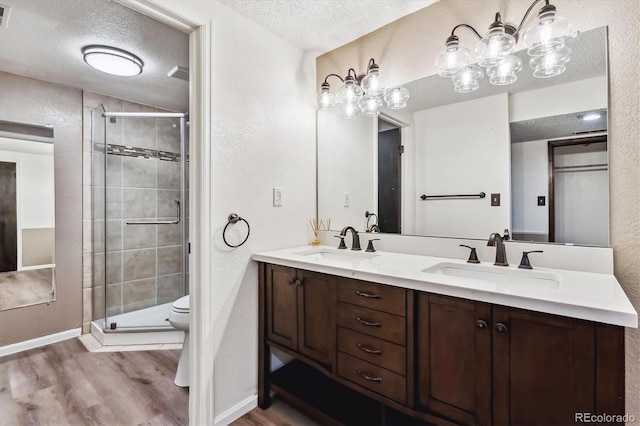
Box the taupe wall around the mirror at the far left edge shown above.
[0,72,82,346]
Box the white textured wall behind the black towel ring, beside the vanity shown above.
[155,0,316,424]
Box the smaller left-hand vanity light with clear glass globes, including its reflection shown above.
[315,58,410,119]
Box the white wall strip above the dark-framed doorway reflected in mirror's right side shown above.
[509,77,608,122]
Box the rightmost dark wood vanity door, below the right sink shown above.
[492,306,595,425]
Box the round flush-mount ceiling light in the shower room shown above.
[82,45,144,77]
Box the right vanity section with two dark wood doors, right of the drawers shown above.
[415,293,624,425]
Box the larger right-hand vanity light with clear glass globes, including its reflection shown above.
[436,0,576,93]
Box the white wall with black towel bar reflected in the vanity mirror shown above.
[414,94,511,238]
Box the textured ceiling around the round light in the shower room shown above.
[0,0,189,111]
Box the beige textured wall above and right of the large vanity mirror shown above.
[316,0,640,417]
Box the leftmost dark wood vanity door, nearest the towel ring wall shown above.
[266,265,298,350]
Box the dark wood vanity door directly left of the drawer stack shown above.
[298,271,336,364]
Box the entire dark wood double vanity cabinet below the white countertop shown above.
[258,263,625,425]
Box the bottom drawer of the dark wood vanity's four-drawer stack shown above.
[338,352,407,404]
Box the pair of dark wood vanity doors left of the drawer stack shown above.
[265,265,335,365]
